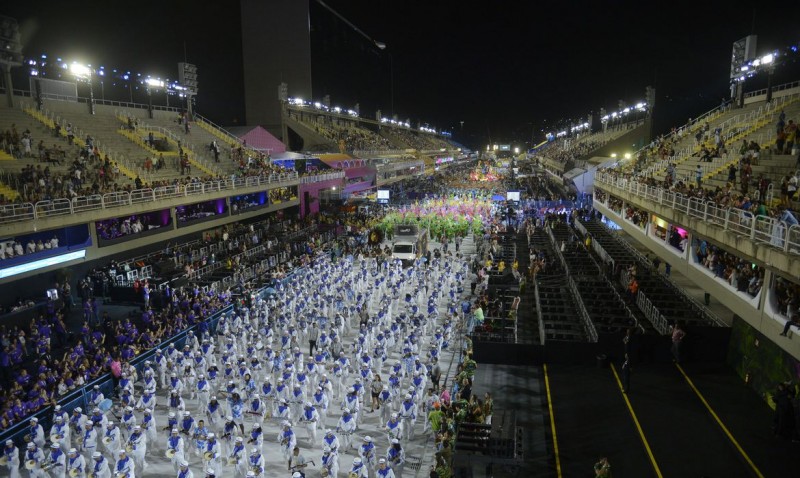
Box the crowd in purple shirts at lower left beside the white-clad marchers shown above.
[0,287,231,429]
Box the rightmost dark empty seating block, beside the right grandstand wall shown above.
[578,219,718,334]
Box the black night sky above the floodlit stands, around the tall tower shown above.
[0,0,800,147]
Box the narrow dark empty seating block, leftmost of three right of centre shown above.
[530,228,588,342]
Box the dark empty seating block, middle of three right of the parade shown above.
[551,222,652,333]
